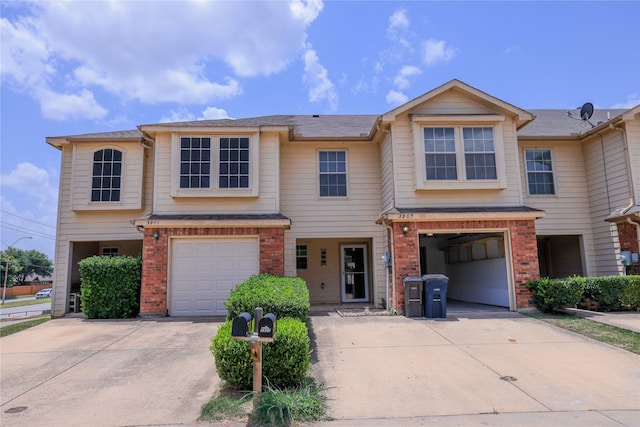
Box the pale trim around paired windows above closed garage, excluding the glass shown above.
[171,132,260,197]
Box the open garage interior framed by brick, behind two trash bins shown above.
[420,233,511,307]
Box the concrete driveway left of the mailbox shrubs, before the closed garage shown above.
[0,318,220,427]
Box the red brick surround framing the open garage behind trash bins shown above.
[389,220,540,312]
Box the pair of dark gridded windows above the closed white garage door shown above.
[174,136,257,197]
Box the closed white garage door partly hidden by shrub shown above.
[169,238,259,316]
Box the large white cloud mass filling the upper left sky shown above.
[1,0,323,119]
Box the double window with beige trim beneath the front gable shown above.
[412,115,506,190]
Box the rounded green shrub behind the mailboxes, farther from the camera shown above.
[225,274,310,322]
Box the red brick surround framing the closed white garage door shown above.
[140,227,284,316]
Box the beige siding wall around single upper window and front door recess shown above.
[280,141,385,302]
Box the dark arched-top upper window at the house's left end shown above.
[91,148,122,202]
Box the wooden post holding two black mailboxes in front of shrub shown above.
[231,307,276,407]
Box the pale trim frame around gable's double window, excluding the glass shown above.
[411,115,507,190]
